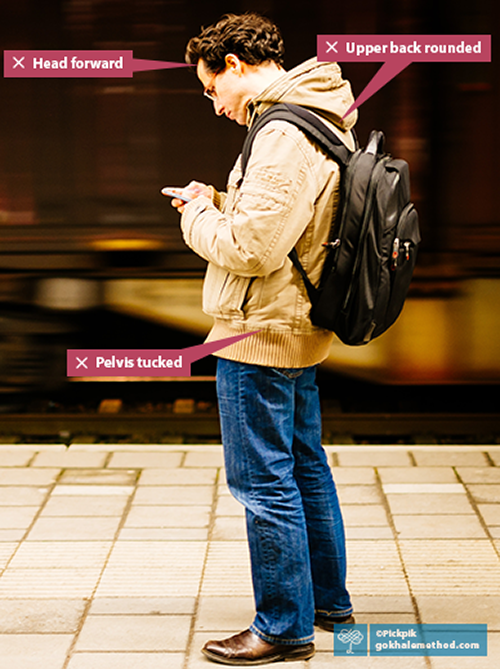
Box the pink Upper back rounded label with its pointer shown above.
[317,35,491,118]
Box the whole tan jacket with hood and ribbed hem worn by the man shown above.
[181,58,356,367]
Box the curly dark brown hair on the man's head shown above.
[186,12,285,72]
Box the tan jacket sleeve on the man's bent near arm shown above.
[181,121,318,276]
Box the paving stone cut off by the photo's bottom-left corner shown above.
[0,634,73,669]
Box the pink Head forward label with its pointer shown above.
[3,49,191,79]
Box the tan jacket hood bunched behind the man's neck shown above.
[248,58,358,132]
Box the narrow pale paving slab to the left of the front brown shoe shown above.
[90,597,196,616]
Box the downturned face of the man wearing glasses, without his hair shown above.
[196,54,255,125]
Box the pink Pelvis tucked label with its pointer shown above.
[66,332,255,377]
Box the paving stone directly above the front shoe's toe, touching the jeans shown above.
[195,597,255,631]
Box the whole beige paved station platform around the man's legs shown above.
[0,444,500,669]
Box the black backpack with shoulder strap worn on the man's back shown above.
[241,103,420,346]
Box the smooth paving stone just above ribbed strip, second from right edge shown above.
[393,514,486,539]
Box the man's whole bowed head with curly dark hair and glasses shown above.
[186,13,284,125]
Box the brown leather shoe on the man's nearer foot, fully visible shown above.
[201,630,314,666]
